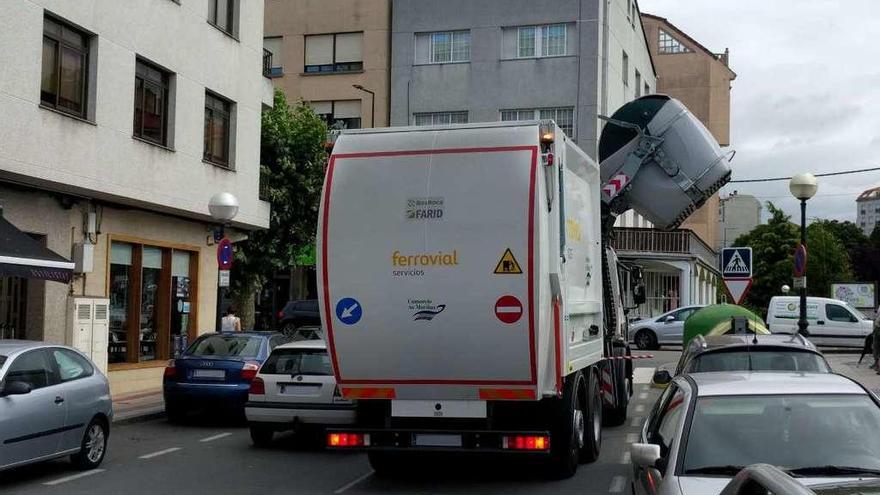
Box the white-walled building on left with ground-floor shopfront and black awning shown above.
[0,0,272,394]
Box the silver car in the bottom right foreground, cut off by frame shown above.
[631,372,880,495]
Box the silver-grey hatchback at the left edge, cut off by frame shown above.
[0,340,113,470]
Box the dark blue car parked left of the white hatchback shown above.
[162,332,287,421]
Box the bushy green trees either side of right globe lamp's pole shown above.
[735,203,858,313]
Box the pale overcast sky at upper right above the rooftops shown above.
[639,0,880,221]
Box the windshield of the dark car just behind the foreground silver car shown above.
[689,350,831,373]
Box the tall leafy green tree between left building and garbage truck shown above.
[232,89,327,328]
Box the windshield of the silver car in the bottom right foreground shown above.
[681,394,880,476]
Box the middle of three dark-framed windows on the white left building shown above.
[134,60,170,146]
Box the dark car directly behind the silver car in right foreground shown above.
[652,334,831,385]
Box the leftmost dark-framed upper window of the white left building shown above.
[40,17,89,118]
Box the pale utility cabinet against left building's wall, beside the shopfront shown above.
[66,297,110,375]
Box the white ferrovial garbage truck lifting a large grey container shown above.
[317,95,730,477]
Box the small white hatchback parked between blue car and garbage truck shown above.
[245,340,356,447]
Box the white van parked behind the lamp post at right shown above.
[767,296,874,348]
